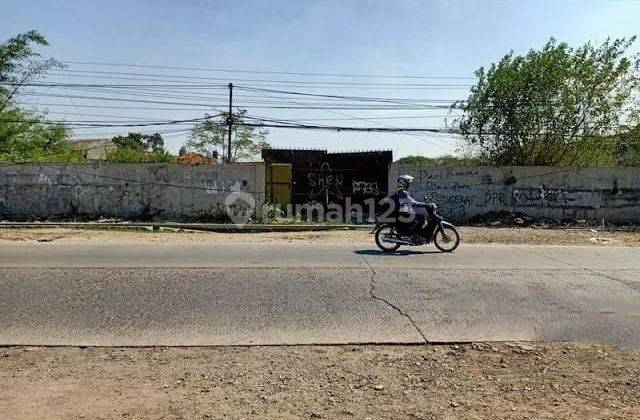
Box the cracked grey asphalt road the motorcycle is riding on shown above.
[0,242,640,347]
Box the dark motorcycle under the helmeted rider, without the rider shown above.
[371,201,460,252]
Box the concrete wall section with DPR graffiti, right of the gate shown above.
[389,164,640,223]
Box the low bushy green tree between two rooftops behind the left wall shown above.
[107,133,174,163]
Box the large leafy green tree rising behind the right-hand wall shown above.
[454,37,639,165]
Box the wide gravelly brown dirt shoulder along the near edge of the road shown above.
[0,344,640,419]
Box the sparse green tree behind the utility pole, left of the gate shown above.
[185,109,270,163]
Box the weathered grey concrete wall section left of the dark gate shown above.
[0,163,264,220]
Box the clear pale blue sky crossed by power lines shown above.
[0,0,640,157]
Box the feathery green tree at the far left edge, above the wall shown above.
[0,31,73,162]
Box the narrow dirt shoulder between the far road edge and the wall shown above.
[0,226,640,246]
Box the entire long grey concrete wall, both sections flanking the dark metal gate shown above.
[0,163,640,223]
